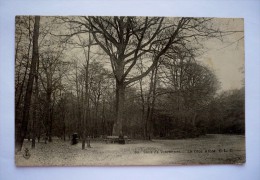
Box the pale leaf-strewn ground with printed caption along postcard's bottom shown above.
[15,135,245,166]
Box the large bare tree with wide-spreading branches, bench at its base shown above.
[60,16,220,135]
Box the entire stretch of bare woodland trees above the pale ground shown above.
[15,16,245,151]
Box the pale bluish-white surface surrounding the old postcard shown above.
[0,0,260,180]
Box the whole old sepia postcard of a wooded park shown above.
[14,16,246,167]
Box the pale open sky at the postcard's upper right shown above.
[199,19,245,91]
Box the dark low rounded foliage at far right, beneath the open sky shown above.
[206,87,245,134]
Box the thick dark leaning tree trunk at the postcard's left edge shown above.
[15,16,40,152]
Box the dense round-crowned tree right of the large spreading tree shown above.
[152,52,219,137]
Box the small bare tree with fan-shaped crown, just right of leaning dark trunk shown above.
[39,40,69,142]
